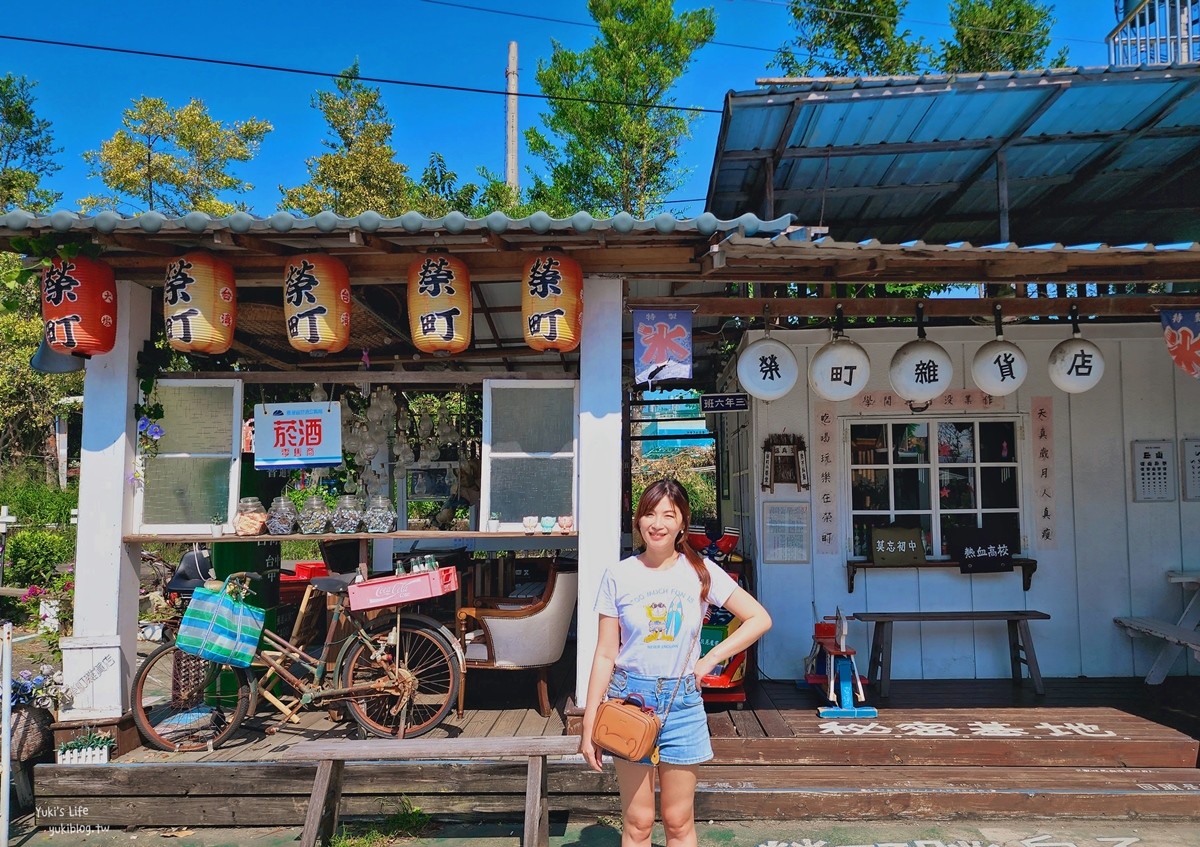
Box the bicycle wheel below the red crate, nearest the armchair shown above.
[340,619,462,738]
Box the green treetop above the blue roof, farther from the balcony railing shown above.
[772,0,930,77]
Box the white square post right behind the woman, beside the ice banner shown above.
[575,276,624,707]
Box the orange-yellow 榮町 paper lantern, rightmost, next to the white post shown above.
[521,253,583,353]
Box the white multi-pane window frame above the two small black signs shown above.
[841,414,1031,560]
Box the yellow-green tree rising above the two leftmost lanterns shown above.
[79,97,272,217]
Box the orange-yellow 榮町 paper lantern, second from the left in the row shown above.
[162,251,238,355]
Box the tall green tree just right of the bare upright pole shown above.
[526,0,715,218]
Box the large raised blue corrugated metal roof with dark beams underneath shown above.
[708,64,1200,244]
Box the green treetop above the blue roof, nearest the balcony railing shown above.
[937,0,1068,73]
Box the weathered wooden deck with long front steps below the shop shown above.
[34,667,1200,827]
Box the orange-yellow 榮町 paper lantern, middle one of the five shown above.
[283,253,350,356]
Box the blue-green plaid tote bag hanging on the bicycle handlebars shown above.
[175,579,264,667]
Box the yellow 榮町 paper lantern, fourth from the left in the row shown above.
[408,253,472,354]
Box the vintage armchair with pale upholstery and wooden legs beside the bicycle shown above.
[456,566,580,717]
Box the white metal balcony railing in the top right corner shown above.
[1108,0,1200,66]
